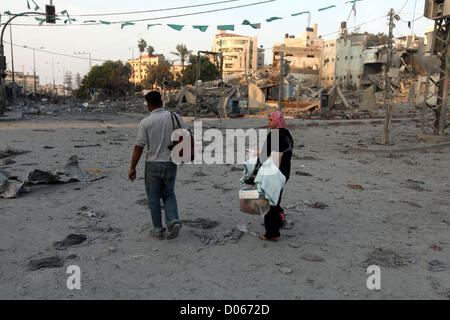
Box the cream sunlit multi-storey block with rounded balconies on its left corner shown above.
[213,31,264,77]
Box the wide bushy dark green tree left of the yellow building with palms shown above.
[74,61,131,98]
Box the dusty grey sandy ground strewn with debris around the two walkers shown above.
[0,114,450,299]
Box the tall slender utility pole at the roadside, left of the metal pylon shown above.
[381,8,395,144]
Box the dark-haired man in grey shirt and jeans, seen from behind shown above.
[128,91,186,240]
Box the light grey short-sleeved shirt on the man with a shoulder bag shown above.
[136,108,187,162]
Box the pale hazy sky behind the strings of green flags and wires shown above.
[0,0,433,84]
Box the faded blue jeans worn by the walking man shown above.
[145,162,180,231]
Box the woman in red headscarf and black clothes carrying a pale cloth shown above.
[255,111,294,241]
